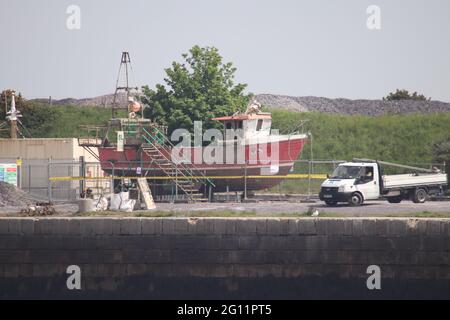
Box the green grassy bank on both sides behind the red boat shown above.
[15,104,450,168]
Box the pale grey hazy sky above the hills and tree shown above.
[0,0,450,101]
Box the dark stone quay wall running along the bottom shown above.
[0,218,450,299]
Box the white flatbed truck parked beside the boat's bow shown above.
[319,159,448,206]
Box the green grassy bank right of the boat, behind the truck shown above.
[272,110,450,168]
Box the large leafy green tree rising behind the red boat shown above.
[141,46,249,134]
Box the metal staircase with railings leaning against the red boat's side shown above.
[141,127,214,202]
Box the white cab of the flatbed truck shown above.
[319,162,381,205]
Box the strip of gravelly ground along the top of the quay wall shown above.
[0,201,450,218]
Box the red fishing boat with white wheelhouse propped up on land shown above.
[79,53,308,201]
